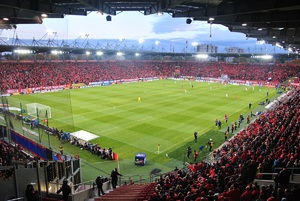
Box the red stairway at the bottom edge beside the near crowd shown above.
[95,183,155,201]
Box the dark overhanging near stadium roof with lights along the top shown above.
[0,0,300,52]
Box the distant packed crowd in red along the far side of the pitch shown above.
[0,61,300,90]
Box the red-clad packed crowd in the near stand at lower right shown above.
[150,89,300,201]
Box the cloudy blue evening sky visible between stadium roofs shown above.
[0,11,283,53]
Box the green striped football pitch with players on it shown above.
[8,80,276,181]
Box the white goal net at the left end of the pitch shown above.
[26,103,51,119]
